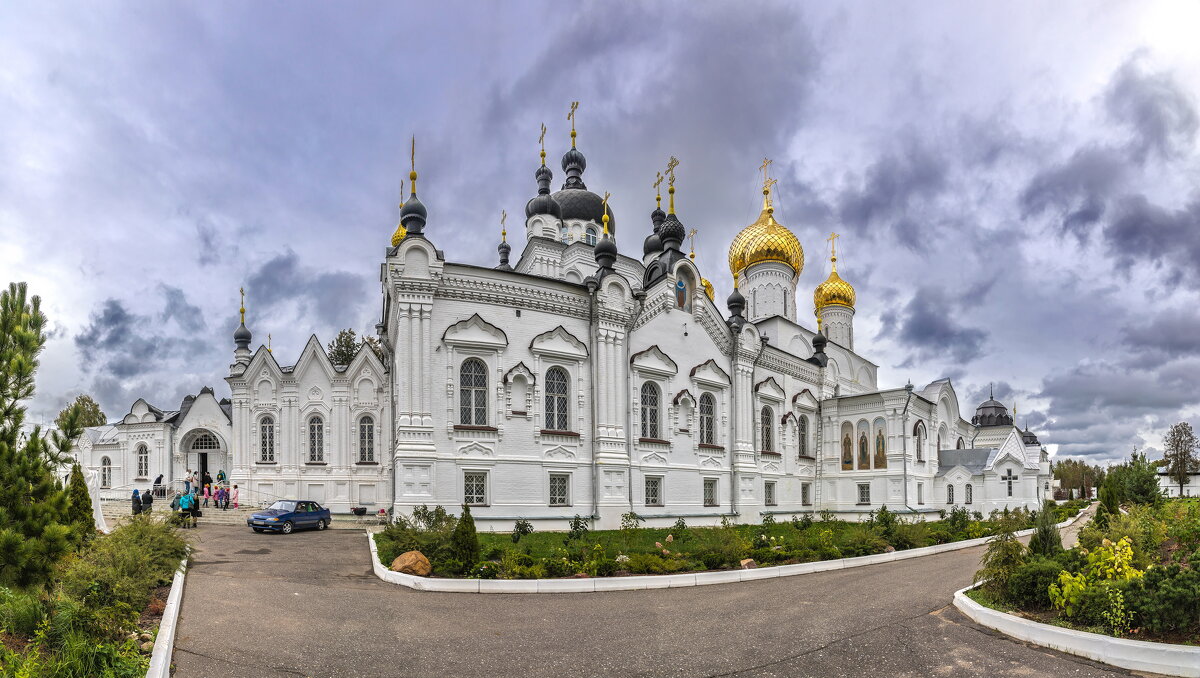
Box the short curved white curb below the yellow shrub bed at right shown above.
[954,586,1200,678]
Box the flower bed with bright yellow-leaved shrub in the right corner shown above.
[966,499,1200,644]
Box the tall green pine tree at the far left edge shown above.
[0,283,72,587]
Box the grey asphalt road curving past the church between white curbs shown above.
[175,508,1129,678]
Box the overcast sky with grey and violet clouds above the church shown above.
[0,0,1200,461]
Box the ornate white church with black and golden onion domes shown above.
[79,121,1050,529]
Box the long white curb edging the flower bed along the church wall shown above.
[366,508,1087,593]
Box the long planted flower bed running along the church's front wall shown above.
[374,502,1086,580]
